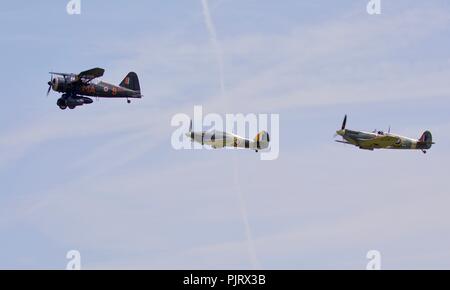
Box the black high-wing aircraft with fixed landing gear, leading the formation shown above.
[47,68,142,110]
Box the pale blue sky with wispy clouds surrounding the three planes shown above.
[0,0,450,269]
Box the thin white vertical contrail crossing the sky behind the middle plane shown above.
[201,0,261,269]
